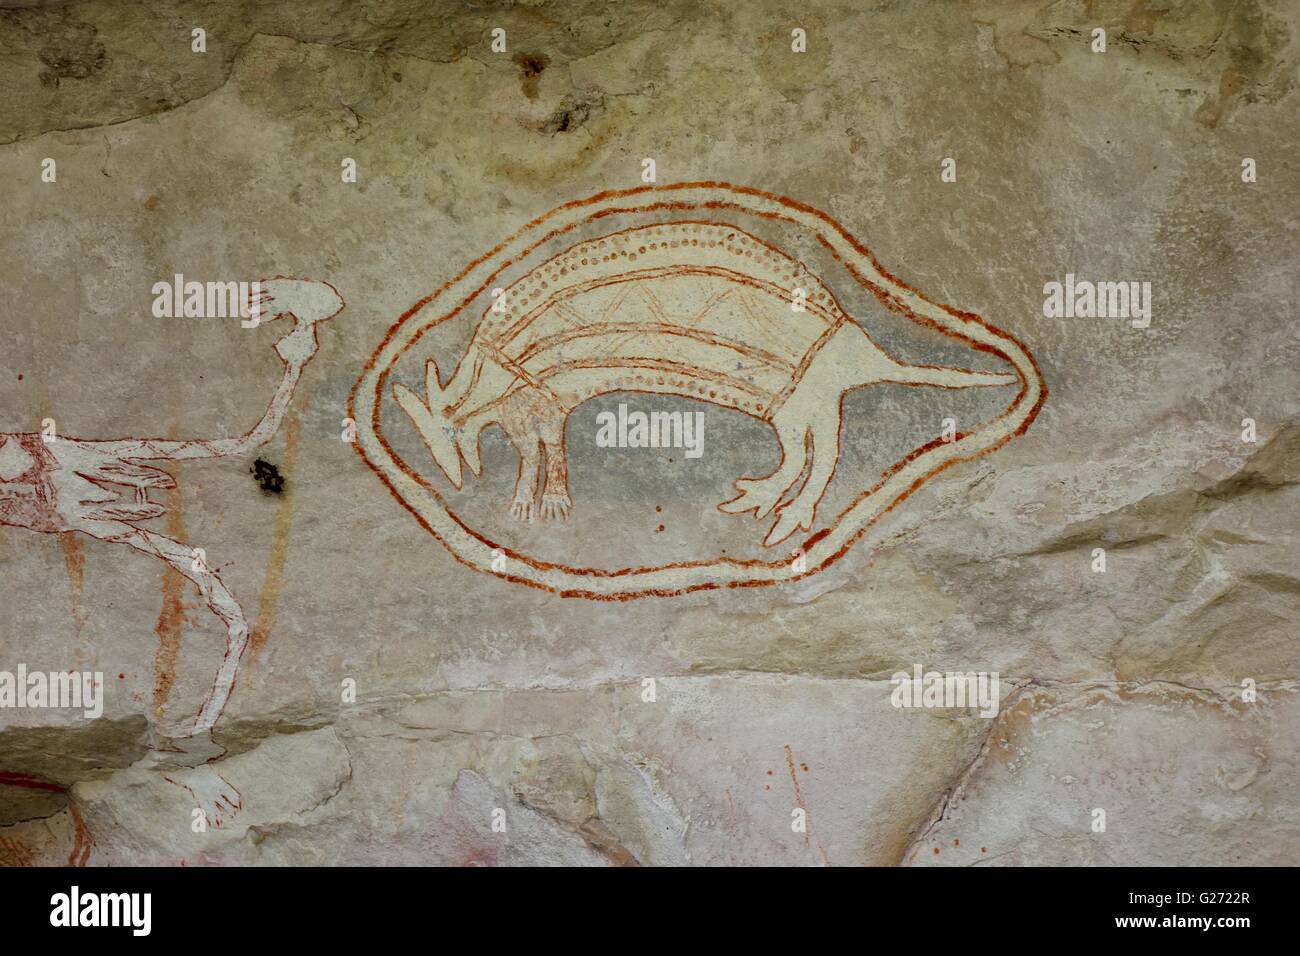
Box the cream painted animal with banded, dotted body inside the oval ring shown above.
[394,220,1019,545]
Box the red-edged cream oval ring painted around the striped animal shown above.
[347,181,1048,601]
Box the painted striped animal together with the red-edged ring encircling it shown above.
[352,182,1047,598]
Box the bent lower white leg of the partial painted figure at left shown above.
[77,522,248,736]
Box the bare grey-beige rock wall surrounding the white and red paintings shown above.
[0,0,1300,865]
